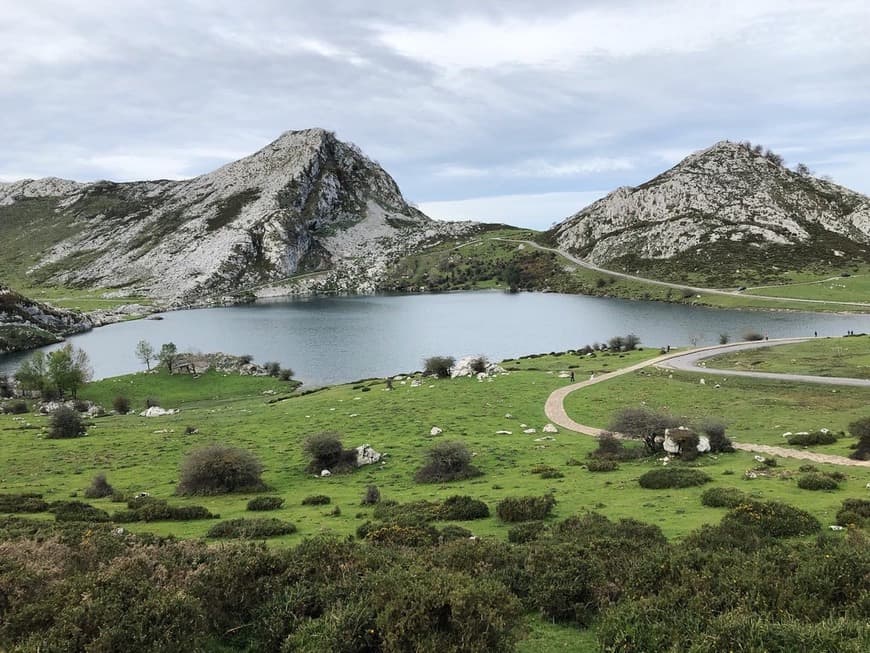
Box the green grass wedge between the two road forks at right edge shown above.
[706,336,870,379]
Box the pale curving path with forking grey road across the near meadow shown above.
[544,338,870,467]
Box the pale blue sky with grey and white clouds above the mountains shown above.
[0,0,870,228]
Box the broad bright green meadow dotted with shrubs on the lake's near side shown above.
[0,349,870,653]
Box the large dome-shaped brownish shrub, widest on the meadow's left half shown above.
[176,444,264,494]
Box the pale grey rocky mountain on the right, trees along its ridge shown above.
[548,141,870,284]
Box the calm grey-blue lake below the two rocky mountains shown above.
[0,291,870,386]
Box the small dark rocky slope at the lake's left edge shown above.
[0,284,94,354]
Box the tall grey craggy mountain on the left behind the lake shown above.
[0,129,472,304]
